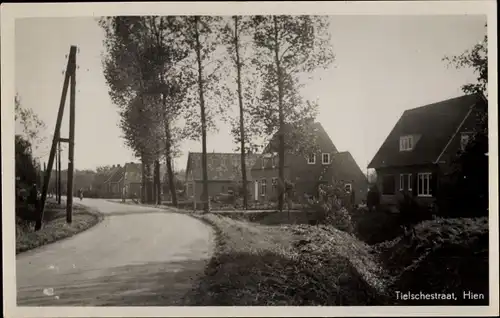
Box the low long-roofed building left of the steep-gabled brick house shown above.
[185,152,257,202]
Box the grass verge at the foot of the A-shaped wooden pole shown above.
[16,203,102,254]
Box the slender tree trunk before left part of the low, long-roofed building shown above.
[194,16,209,213]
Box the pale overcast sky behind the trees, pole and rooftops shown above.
[15,15,486,170]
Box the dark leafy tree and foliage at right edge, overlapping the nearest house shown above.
[439,26,489,216]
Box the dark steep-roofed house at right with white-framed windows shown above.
[368,94,487,206]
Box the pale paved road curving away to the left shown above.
[16,199,214,306]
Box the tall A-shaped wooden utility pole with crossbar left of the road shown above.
[35,46,76,231]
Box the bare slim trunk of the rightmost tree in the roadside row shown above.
[273,16,285,212]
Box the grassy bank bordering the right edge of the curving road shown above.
[189,214,386,306]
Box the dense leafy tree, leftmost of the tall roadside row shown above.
[99,16,158,202]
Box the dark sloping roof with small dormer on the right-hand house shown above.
[368,94,484,169]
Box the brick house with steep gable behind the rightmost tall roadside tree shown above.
[252,122,368,204]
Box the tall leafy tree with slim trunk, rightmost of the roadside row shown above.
[251,16,334,211]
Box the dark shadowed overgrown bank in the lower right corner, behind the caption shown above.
[378,218,489,305]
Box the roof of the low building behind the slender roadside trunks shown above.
[186,152,258,181]
